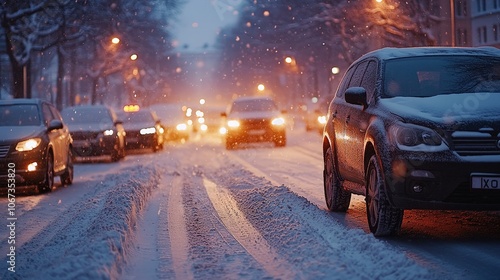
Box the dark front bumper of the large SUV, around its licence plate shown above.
[386,153,500,210]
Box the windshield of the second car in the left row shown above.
[62,108,112,124]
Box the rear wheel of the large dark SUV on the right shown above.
[323,148,351,212]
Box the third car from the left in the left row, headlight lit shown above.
[120,109,164,152]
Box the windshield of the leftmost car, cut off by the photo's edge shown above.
[0,104,41,126]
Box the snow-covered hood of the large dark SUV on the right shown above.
[379,93,500,129]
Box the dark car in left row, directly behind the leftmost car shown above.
[61,105,125,161]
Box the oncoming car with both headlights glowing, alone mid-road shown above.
[221,97,286,150]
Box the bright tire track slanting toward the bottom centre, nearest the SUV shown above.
[203,178,295,279]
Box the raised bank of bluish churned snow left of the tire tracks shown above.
[0,166,159,279]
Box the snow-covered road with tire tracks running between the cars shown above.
[0,125,500,279]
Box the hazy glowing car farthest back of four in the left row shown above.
[149,104,192,141]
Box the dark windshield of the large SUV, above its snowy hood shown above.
[382,56,500,98]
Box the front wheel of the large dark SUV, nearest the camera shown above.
[365,155,403,236]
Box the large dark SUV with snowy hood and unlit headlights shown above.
[323,47,500,236]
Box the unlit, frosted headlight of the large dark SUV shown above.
[389,123,448,152]
